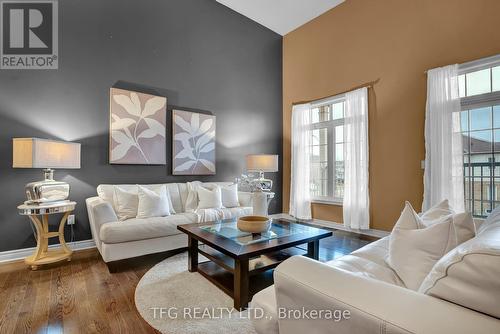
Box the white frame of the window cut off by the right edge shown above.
[458,55,500,219]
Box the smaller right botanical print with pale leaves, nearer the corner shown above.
[172,110,215,175]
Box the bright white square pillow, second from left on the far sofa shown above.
[136,186,170,218]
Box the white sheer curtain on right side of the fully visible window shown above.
[343,87,370,229]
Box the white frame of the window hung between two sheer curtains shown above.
[310,94,345,205]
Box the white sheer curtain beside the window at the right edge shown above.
[422,64,465,212]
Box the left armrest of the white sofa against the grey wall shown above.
[85,197,118,250]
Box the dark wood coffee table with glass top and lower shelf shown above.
[177,219,332,310]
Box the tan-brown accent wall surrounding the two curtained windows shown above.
[283,0,500,230]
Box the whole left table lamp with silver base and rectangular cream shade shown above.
[12,138,80,204]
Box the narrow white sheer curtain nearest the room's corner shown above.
[289,103,311,219]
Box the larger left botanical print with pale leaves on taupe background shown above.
[109,88,167,165]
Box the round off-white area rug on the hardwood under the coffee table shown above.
[135,253,255,334]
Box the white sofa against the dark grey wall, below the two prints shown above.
[86,182,252,262]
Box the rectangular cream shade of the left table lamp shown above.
[12,138,80,169]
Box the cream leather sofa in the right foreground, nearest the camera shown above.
[250,219,500,334]
